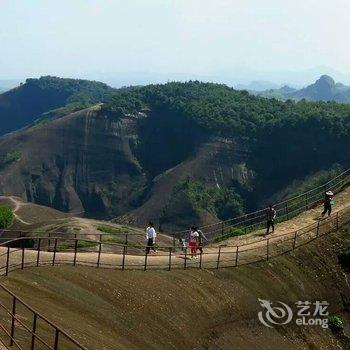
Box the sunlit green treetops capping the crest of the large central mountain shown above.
[104,81,350,137]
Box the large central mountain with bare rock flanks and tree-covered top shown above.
[0,82,350,229]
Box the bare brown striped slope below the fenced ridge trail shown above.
[1,231,350,350]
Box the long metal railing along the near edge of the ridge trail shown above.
[0,207,350,275]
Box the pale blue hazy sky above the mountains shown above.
[0,0,350,84]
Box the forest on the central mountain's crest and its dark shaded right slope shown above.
[103,81,350,201]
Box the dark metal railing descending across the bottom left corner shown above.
[0,284,87,350]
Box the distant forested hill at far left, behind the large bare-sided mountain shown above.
[0,76,113,135]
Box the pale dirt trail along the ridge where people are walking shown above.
[0,187,350,274]
